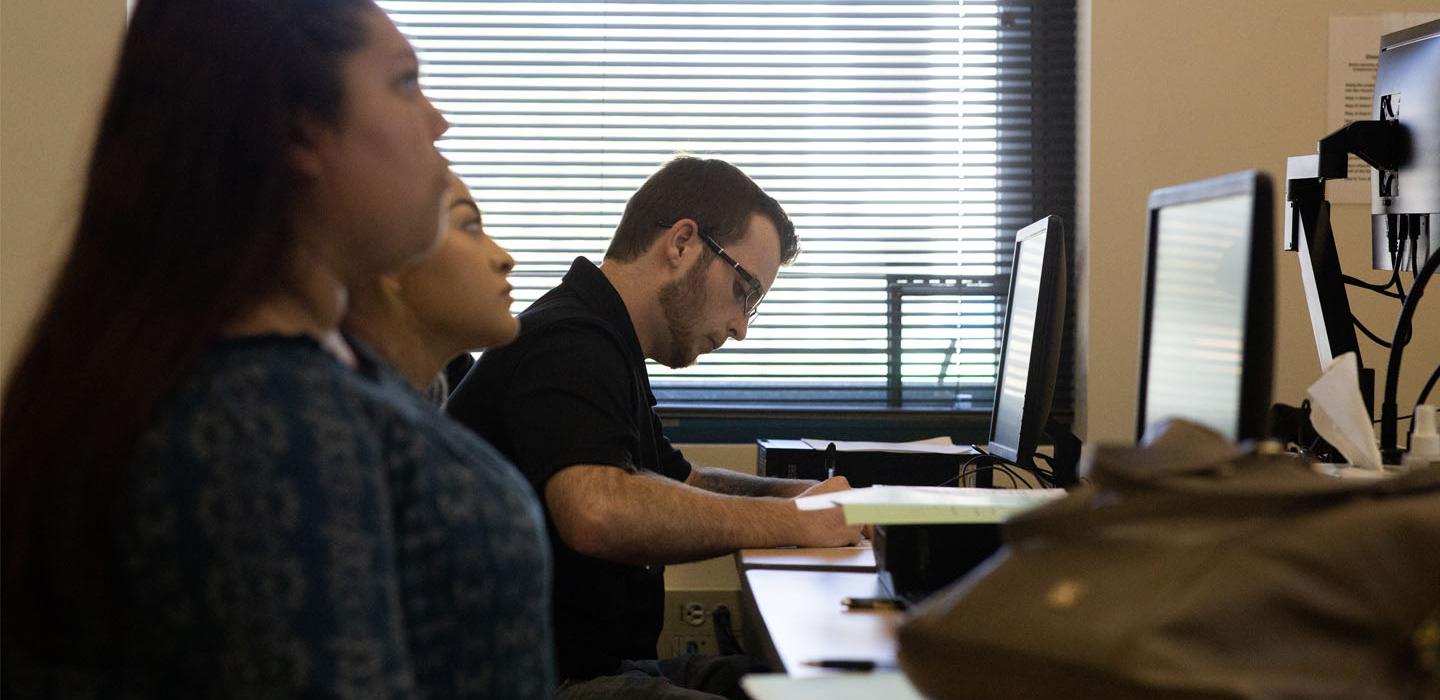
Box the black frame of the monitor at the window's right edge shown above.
[985,216,1067,467]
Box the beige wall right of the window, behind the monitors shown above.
[1080,0,1440,442]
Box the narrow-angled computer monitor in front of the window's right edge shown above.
[988,216,1068,467]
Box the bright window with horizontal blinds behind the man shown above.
[380,0,1074,432]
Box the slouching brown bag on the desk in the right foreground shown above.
[899,420,1440,700]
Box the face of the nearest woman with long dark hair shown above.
[300,6,449,282]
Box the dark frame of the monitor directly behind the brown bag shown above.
[1135,170,1274,441]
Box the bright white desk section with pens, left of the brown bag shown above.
[742,569,903,677]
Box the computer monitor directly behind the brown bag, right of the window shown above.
[1136,171,1274,441]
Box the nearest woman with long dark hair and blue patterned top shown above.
[0,0,553,697]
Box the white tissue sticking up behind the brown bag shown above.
[1305,353,1381,470]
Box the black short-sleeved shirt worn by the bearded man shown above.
[445,258,690,678]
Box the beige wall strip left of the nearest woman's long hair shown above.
[0,0,125,386]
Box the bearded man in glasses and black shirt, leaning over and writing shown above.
[446,156,860,699]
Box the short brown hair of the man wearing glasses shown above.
[605,156,799,265]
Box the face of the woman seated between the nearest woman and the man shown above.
[399,176,520,349]
